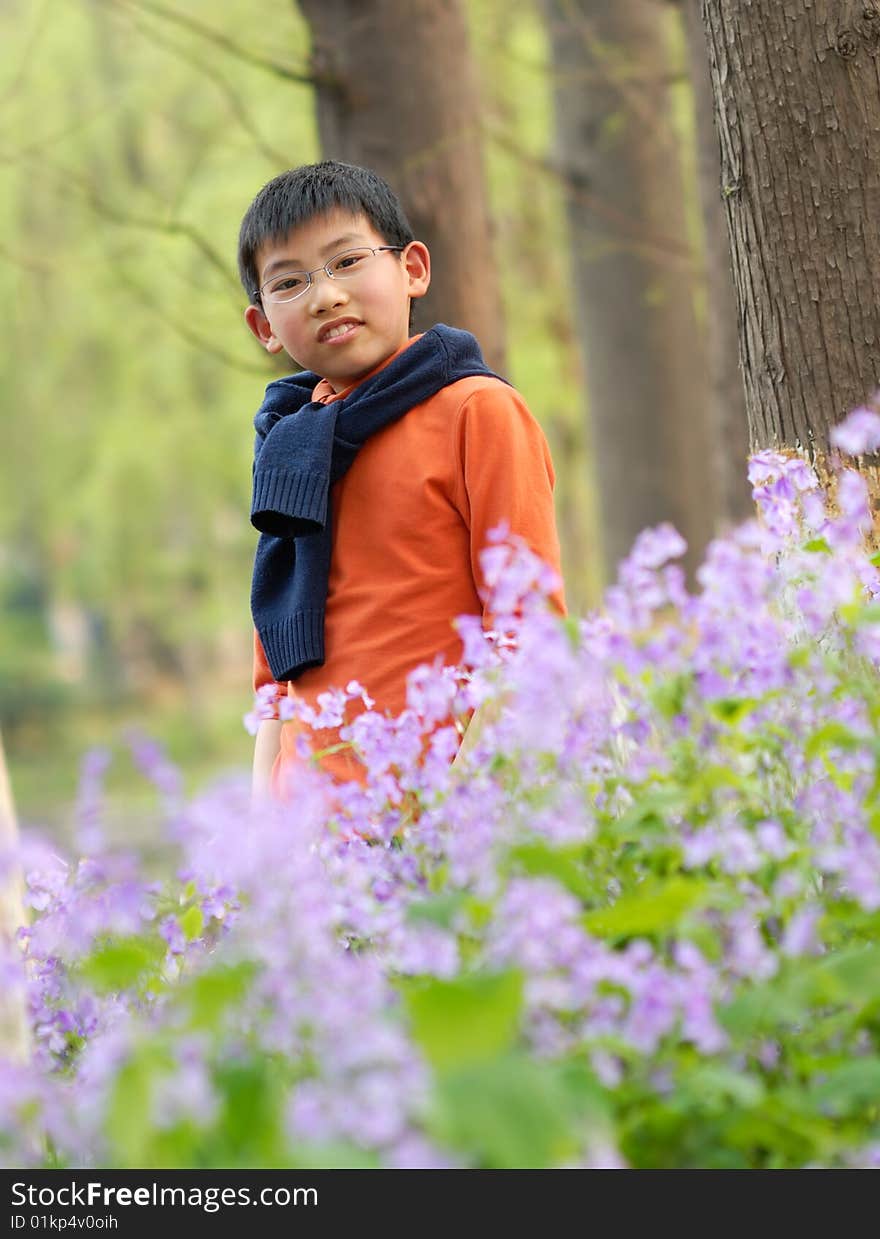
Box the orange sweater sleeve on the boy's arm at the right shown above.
[456,383,565,615]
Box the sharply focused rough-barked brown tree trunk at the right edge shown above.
[703,0,880,466]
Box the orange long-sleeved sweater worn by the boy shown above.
[254,346,565,789]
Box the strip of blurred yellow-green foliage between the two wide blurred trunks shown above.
[467,0,601,611]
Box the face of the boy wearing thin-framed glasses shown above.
[244,209,430,392]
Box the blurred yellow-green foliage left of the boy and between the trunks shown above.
[0,0,596,828]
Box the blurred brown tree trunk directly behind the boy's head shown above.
[300,0,504,369]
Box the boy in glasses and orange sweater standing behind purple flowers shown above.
[238,161,564,797]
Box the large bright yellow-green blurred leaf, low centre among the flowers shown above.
[404,971,523,1069]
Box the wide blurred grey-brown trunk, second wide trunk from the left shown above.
[544,0,714,576]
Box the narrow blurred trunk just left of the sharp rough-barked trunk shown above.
[682,0,755,525]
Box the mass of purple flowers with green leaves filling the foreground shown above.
[0,409,880,1167]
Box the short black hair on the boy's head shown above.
[238,160,414,305]
